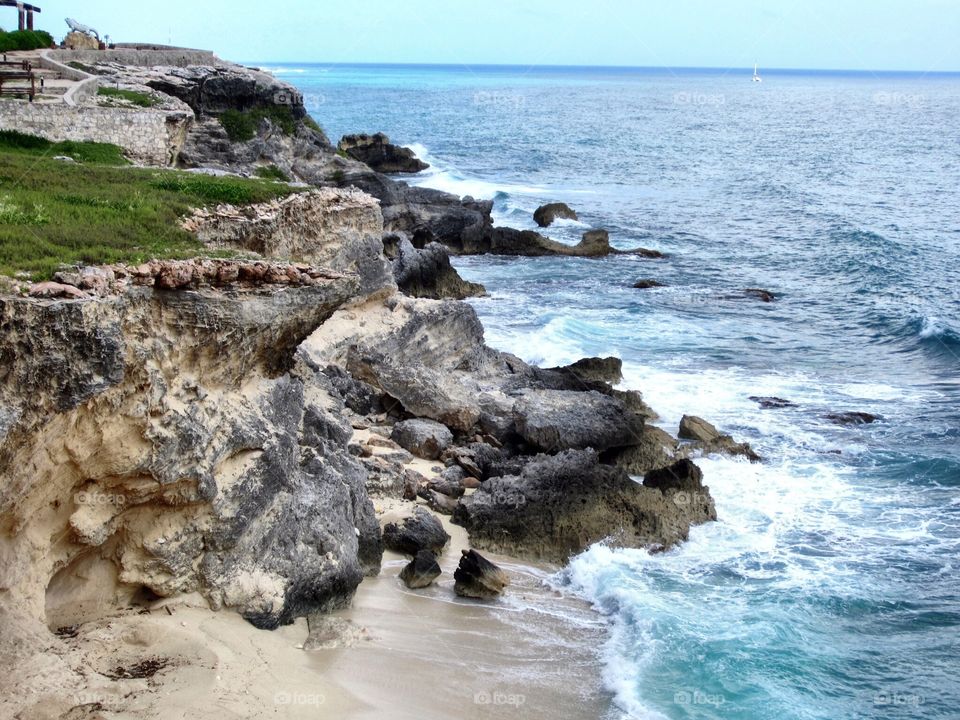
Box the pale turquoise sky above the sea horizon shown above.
[18,0,960,72]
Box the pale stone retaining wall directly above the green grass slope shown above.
[0,100,193,167]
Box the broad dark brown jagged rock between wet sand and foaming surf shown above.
[453,450,716,563]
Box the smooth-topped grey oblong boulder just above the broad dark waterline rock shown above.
[514,390,644,452]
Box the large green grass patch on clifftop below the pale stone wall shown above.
[0,133,293,280]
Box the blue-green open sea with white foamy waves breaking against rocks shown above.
[273,65,960,720]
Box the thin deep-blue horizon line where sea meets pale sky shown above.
[241,60,960,76]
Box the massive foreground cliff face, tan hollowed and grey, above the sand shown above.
[0,279,382,627]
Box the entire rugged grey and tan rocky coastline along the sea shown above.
[0,47,760,717]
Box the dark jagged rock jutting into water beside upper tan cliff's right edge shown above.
[384,235,486,300]
